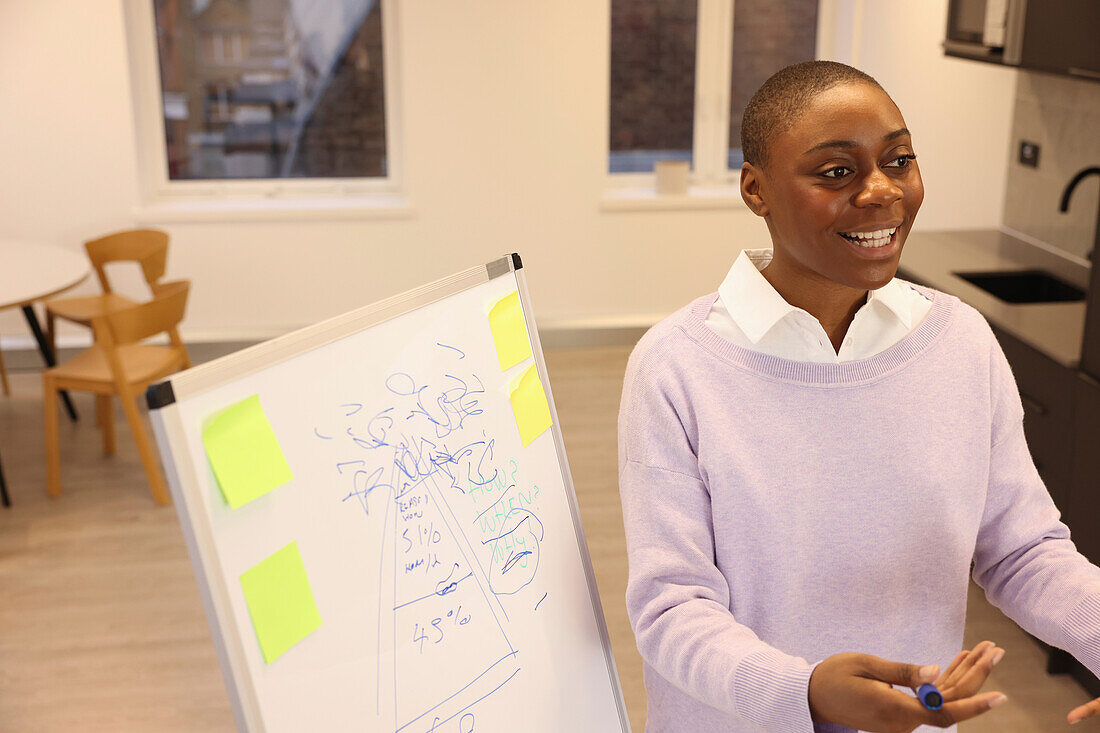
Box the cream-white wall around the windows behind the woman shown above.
[0,0,1014,347]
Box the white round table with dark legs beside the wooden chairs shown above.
[0,239,91,506]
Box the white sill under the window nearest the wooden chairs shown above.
[134,195,416,225]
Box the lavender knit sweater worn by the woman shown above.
[619,286,1100,733]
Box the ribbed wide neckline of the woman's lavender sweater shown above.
[681,283,956,384]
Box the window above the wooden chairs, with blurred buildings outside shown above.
[128,0,394,198]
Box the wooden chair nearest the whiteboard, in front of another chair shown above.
[42,281,191,504]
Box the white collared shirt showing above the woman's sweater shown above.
[706,250,932,364]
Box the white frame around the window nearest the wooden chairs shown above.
[123,0,411,222]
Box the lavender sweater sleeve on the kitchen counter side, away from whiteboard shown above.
[974,330,1100,676]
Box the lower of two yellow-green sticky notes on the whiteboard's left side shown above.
[241,541,321,664]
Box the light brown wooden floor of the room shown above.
[0,348,1100,733]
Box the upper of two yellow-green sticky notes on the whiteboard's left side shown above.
[202,394,294,508]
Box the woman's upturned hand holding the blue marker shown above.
[810,642,1007,733]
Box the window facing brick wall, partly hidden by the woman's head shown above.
[607,0,817,184]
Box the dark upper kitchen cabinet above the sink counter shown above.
[944,0,1100,81]
